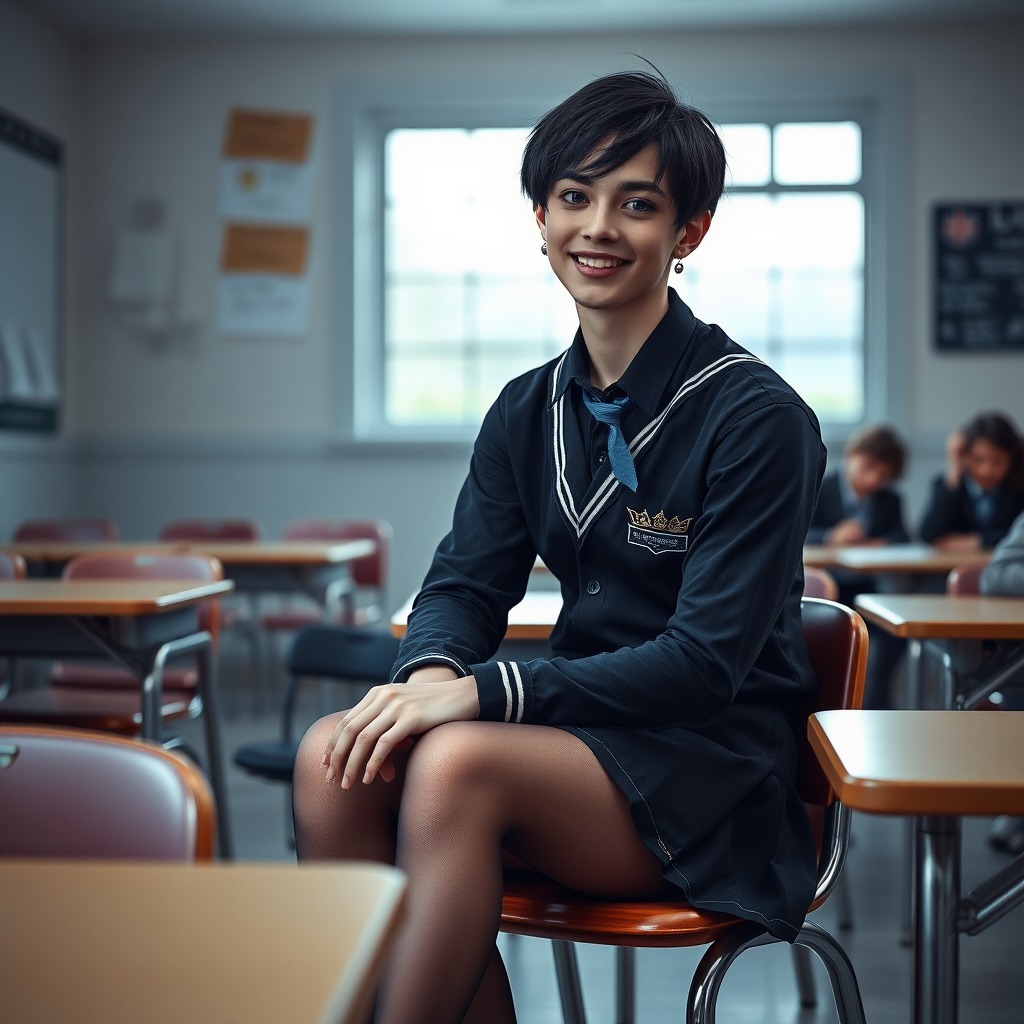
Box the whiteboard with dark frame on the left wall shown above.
[0,111,63,431]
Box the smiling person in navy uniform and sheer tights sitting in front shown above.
[295,74,825,1024]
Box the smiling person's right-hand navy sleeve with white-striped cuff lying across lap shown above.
[471,404,824,726]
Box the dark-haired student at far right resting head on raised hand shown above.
[921,413,1024,554]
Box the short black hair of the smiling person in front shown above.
[521,72,725,227]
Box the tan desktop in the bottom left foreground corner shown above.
[0,860,406,1024]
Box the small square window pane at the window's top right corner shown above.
[774,121,860,185]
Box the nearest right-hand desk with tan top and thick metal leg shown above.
[808,711,1024,1024]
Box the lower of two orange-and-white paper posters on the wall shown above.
[217,224,309,336]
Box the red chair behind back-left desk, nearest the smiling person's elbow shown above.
[260,519,394,633]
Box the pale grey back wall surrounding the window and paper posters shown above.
[37,19,1024,600]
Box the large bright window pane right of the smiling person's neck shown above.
[677,191,864,423]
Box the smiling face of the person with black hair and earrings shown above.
[536,143,711,309]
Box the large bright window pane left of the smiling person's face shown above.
[384,128,579,426]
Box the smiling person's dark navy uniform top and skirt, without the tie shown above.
[394,291,825,939]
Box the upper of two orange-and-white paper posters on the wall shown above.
[219,111,312,224]
